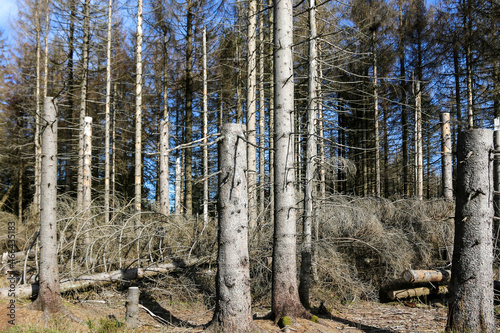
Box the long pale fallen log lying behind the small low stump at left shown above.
[0,259,201,299]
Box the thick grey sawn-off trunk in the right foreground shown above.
[448,129,496,332]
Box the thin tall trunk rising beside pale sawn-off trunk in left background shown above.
[76,0,90,211]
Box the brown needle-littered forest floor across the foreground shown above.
[0,282,494,333]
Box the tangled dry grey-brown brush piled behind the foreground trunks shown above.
[2,195,453,305]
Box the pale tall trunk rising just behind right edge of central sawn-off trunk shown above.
[247,0,257,233]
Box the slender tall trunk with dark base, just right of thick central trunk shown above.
[299,0,318,308]
